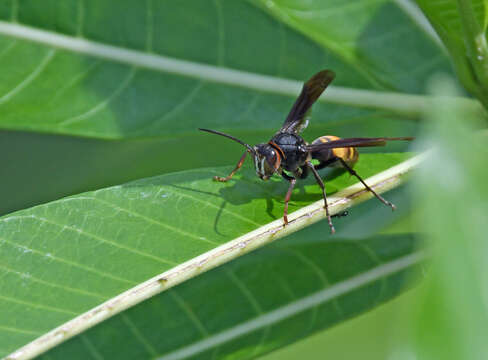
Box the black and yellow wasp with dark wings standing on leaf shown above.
[199,70,414,234]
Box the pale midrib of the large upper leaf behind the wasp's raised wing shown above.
[0,21,480,123]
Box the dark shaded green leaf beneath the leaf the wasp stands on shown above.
[41,233,422,360]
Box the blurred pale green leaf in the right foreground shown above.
[411,79,488,360]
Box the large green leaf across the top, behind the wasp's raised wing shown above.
[0,0,458,138]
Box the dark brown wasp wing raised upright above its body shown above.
[279,70,335,134]
